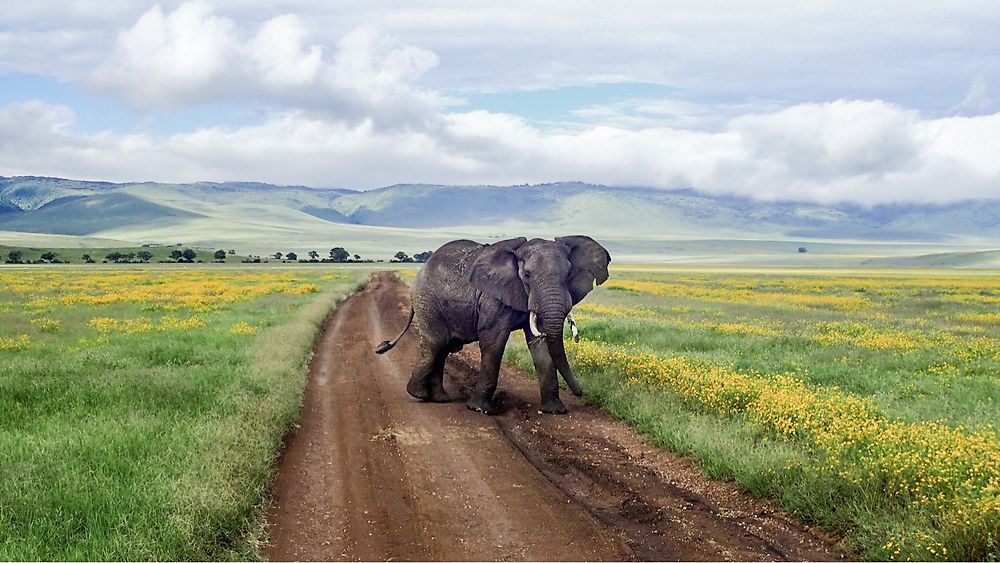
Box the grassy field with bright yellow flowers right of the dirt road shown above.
[508,267,1000,560]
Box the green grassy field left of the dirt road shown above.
[0,266,369,560]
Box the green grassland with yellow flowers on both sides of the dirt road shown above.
[0,265,1000,560]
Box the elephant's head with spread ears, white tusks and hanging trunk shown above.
[470,235,611,395]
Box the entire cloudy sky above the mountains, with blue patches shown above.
[0,0,1000,205]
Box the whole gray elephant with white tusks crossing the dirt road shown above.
[376,235,611,414]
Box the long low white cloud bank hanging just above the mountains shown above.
[0,101,1000,204]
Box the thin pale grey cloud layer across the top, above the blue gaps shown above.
[9,0,1000,111]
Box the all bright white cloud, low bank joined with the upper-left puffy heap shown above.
[0,2,1000,205]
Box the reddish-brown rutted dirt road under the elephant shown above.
[265,274,843,560]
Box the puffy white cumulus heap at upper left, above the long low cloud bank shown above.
[88,2,444,127]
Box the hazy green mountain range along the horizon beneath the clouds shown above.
[0,176,1000,264]
